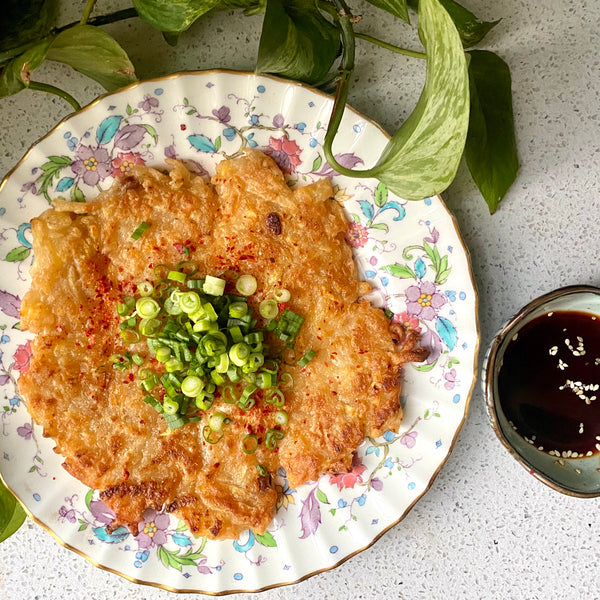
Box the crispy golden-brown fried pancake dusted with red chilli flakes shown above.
[19,151,425,539]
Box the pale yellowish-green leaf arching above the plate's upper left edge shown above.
[47,25,136,91]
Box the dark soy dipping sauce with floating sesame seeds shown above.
[498,311,600,456]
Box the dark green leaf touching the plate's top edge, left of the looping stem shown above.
[256,0,340,83]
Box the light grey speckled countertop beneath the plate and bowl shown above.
[0,0,600,600]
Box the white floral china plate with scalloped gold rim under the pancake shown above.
[0,71,479,593]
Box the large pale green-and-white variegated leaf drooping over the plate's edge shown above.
[369,0,469,200]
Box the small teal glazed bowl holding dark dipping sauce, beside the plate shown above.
[482,285,600,498]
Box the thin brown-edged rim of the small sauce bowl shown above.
[482,284,600,498]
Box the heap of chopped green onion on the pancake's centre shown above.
[111,261,314,436]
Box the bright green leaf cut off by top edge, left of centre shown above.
[133,0,220,33]
